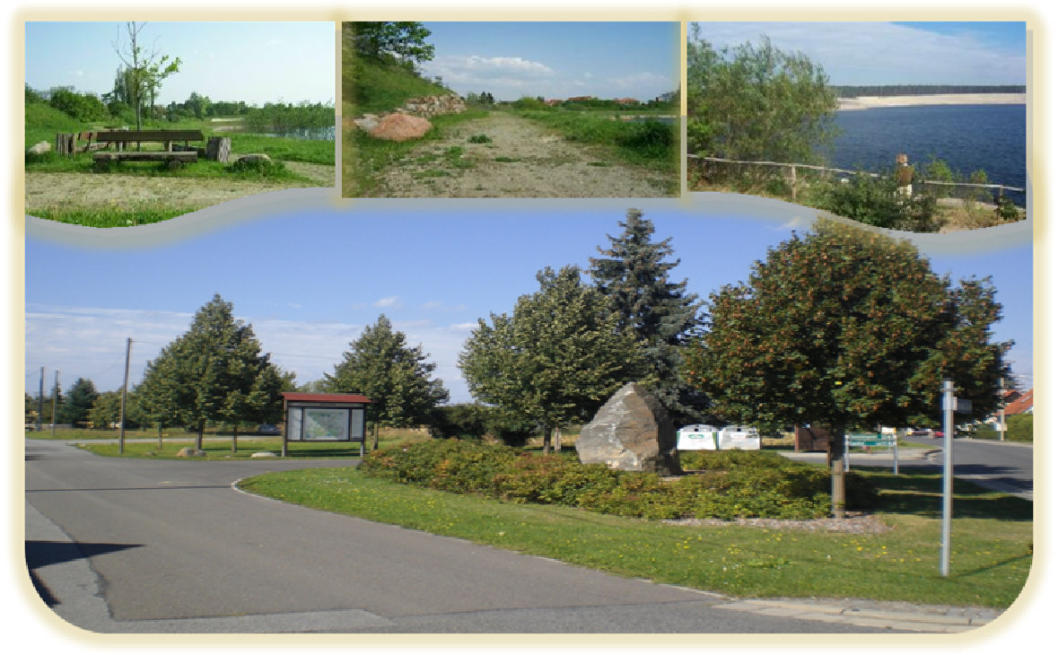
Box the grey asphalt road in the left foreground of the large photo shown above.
[25,440,889,633]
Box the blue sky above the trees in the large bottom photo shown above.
[24,202,1033,402]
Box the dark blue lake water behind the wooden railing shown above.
[828,105,1026,204]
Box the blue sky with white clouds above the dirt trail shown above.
[414,21,679,101]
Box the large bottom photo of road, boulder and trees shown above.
[24,201,1034,644]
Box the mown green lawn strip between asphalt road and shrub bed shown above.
[241,469,1032,607]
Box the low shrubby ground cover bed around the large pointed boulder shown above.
[361,439,873,518]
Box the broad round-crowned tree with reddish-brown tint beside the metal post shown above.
[686,221,1009,517]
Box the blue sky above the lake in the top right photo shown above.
[689,21,1026,85]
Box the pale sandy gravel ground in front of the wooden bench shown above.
[25,162,334,215]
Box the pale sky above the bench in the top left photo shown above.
[25,21,335,105]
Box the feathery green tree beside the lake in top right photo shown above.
[687,25,838,162]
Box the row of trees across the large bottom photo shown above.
[26,210,1011,513]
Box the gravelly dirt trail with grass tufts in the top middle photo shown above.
[368,112,674,198]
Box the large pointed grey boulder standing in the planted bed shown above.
[577,383,680,475]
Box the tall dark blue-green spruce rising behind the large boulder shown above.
[590,210,703,420]
